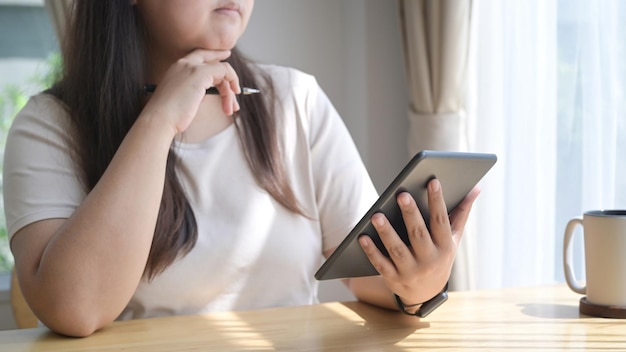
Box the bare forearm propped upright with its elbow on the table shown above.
[21,113,173,336]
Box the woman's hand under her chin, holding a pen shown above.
[142,49,241,134]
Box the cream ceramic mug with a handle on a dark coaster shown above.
[563,210,626,307]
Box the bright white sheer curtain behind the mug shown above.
[468,0,626,288]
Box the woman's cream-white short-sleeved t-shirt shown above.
[4,66,377,319]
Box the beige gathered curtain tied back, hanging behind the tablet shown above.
[399,0,474,290]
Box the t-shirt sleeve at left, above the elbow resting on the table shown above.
[2,94,85,238]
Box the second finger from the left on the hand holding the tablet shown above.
[371,213,417,275]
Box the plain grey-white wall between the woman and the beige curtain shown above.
[239,0,409,300]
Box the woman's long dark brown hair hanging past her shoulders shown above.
[50,0,303,279]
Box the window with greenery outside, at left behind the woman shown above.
[0,0,59,272]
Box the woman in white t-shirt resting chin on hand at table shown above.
[4,0,477,336]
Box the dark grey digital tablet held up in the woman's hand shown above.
[315,150,497,280]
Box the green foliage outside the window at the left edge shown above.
[0,53,62,272]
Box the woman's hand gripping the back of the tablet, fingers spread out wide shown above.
[359,179,480,305]
